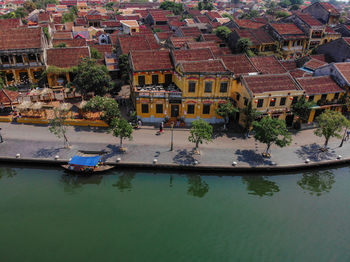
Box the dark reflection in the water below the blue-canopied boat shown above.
[60,174,103,194]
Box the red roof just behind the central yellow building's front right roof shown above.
[172,48,214,63]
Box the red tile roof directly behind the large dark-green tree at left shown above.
[46,46,90,68]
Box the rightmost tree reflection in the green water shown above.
[297,170,335,196]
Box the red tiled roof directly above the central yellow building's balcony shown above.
[130,50,173,71]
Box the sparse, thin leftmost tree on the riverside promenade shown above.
[49,109,70,148]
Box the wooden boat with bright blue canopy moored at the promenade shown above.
[62,155,114,173]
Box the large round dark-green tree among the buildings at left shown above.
[73,58,111,97]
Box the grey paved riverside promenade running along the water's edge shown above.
[0,123,350,170]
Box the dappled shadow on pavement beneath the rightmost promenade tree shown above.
[295,143,336,162]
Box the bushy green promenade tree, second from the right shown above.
[253,116,292,154]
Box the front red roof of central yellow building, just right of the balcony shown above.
[181,59,229,73]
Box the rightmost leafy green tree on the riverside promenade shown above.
[314,110,347,149]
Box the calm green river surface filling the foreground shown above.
[0,166,350,262]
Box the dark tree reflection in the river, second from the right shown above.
[242,176,280,197]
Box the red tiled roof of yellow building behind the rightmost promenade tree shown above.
[297,76,344,95]
